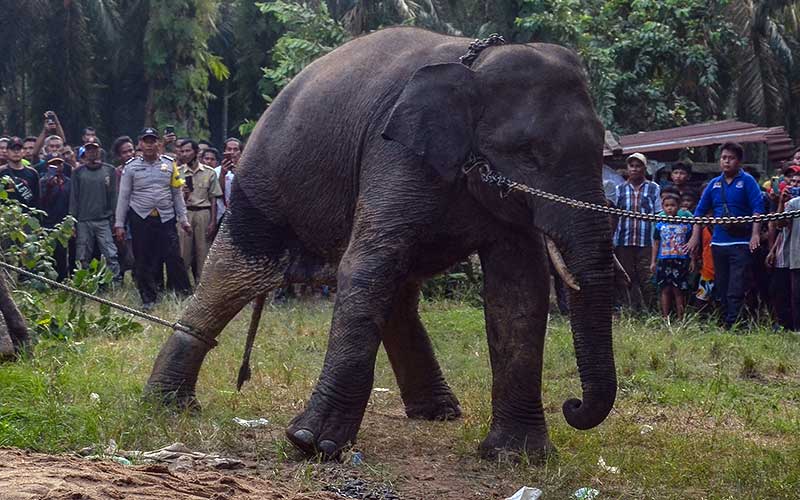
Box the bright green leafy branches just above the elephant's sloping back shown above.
[257,0,348,102]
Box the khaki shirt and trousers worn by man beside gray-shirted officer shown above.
[178,163,222,283]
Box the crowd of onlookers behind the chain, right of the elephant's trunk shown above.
[608,143,800,330]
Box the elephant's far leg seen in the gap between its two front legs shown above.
[382,283,461,420]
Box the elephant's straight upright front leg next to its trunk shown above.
[480,236,555,460]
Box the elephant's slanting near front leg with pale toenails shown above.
[286,241,405,459]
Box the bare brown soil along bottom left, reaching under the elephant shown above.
[0,409,520,500]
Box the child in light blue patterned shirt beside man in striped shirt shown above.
[650,193,695,320]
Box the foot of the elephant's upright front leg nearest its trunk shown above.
[480,429,557,464]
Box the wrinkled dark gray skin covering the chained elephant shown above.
[147,28,616,457]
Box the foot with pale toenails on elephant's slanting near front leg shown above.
[286,393,364,460]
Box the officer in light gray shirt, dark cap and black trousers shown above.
[114,128,192,310]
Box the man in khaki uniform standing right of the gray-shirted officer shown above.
[178,140,222,283]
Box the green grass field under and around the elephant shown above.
[0,292,800,499]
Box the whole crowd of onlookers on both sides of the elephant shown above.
[0,111,800,330]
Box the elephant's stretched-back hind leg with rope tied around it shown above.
[145,225,289,408]
